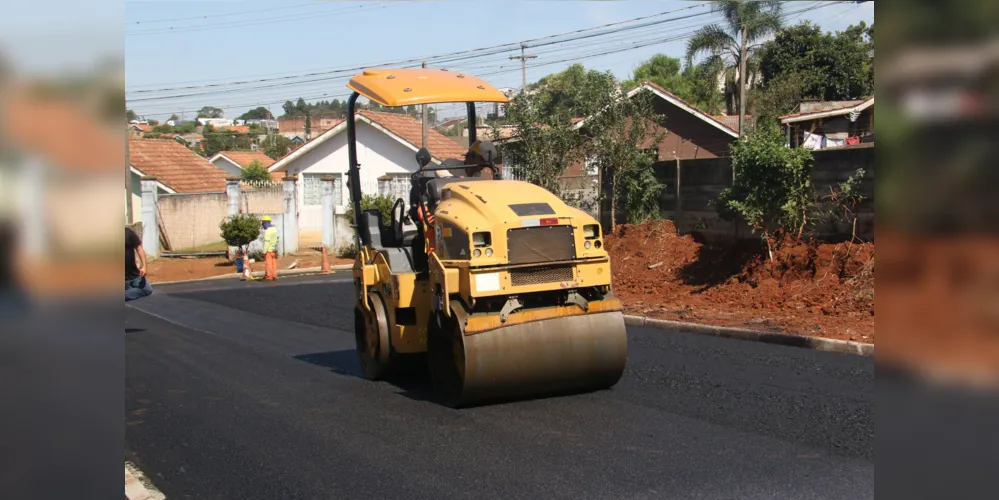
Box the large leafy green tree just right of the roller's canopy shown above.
[504,65,662,220]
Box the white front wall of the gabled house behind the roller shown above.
[288,120,419,231]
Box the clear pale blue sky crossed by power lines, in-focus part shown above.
[118,0,874,120]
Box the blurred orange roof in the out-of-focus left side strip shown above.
[0,88,125,173]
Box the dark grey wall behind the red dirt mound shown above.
[601,144,875,240]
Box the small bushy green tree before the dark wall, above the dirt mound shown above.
[715,126,815,260]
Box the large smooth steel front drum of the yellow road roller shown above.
[428,311,627,407]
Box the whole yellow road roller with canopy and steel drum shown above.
[346,69,627,407]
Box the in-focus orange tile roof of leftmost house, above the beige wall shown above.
[128,137,227,193]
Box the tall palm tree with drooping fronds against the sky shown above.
[687,0,782,136]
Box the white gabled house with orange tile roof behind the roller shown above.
[269,110,466,241]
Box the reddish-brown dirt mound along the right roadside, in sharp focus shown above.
[605,221,874,342]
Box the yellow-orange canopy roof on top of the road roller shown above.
[347,68,509,107]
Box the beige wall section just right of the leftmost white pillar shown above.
[157,192,229,252]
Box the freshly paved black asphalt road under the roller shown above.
[125,275,874,499]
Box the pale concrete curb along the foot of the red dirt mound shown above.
[624,314,874,356]
